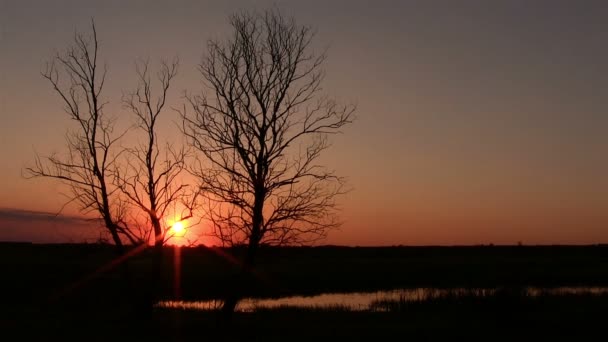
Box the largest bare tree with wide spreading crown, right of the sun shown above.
[182,10,354,311]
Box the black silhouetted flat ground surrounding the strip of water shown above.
[0,244,608,341]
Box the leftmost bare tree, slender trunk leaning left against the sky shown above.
[26,21,141,252]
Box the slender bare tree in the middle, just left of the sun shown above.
[115,59,195,248]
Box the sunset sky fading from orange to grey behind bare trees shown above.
[0,0,608,246]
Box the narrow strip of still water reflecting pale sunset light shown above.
[157,287,608,312]
